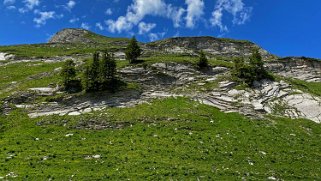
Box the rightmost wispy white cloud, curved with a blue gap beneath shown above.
[210,0,252,32]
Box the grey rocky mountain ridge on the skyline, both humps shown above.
[48,28,276,59]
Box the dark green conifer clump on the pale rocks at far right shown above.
[232,50,272,86]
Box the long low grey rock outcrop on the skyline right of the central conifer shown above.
[144,37,275,59]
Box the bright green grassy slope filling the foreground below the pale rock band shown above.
[0,98,321,180]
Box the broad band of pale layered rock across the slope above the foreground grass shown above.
[21,63,321,123]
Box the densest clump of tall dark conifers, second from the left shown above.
[83,52,119,92]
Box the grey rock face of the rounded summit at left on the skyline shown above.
[48,29,94,43]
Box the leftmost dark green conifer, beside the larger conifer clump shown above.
[60,60,82,92]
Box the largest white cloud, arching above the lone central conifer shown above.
[106,0,183,33]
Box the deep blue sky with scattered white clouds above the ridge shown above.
[0,0,321,58]
